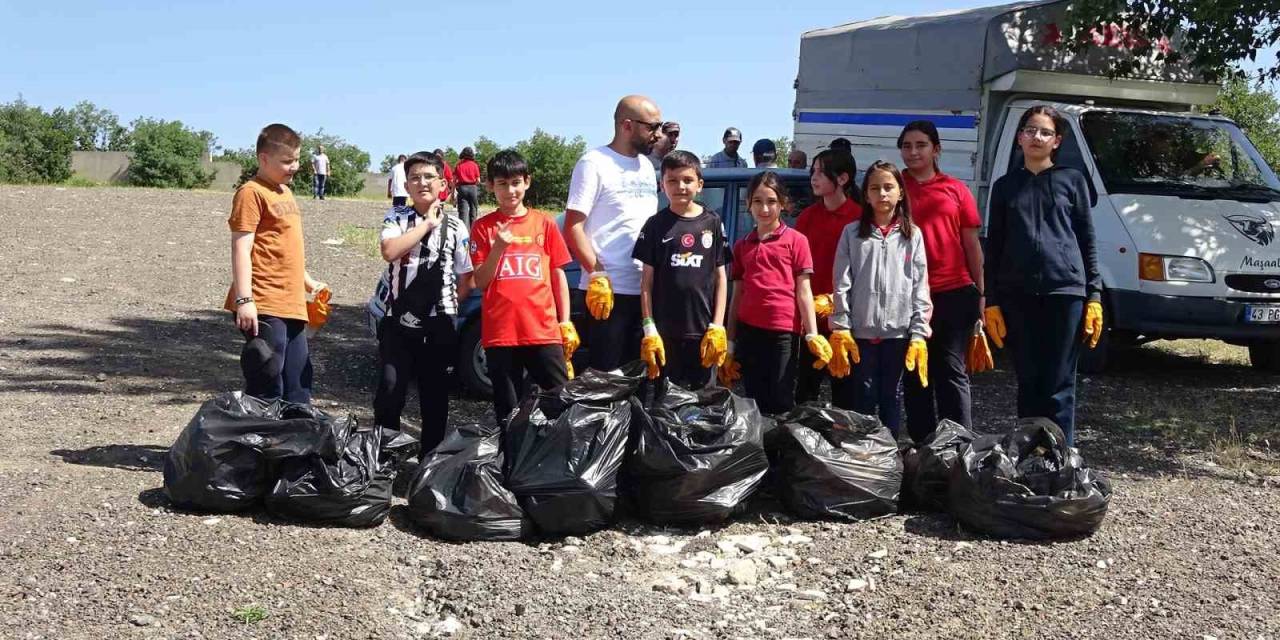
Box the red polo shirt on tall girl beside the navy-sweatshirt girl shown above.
[902,173,982,293]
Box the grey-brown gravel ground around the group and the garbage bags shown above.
[0,187,1280,640]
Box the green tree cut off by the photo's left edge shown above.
[0,96,74,182]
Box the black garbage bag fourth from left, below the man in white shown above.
[503,365,643,535]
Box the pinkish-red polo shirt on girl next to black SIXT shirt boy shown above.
[731,224,813,333]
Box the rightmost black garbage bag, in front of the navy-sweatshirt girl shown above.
[948,417,1111,540]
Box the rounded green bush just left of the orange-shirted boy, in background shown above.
[128,118,215,189]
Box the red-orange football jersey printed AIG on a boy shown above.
[471,209,570,347]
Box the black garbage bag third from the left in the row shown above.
[408,425,532,540]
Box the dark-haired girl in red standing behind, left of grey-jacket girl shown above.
[796,148,863,410]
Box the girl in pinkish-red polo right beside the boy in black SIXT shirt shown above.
[721,172,831,413]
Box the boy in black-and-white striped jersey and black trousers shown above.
[374,151,474,457]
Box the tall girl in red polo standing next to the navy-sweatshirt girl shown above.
[897,120,989,443]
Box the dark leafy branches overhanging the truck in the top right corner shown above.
[1064,0,1280,79]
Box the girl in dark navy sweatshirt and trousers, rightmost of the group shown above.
[983,105,1102,444]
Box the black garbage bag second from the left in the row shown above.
[266,428,419,526]
